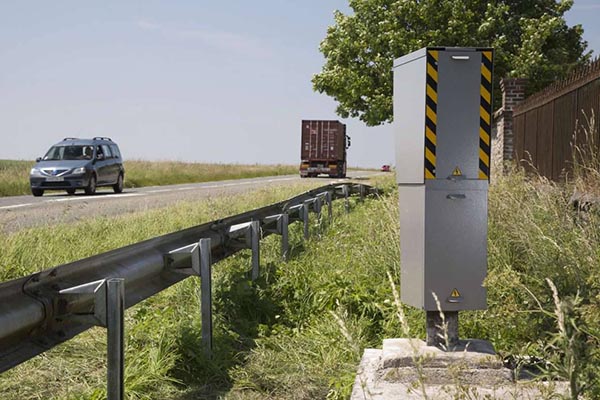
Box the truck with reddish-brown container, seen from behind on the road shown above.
[300,120,350,178]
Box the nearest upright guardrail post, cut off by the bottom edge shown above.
[106,278,125,400]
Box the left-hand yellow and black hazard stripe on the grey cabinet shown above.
[425,50,438,179]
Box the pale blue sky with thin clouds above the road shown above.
[0,0,600,167]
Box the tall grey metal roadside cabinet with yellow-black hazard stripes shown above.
[394,48,493,311]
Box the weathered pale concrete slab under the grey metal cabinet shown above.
[351,339,568,400]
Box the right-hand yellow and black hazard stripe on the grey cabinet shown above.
[479,50,493,179]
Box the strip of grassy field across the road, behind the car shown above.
[0,160,298,196]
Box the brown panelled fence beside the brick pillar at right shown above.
[513,59,600,181]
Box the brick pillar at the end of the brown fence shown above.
[497,78,527,160]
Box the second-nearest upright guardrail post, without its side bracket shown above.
[198,238,212,358]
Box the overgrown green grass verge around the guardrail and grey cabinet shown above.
[0,165,600,400]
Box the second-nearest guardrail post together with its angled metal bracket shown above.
[165,238,212,358]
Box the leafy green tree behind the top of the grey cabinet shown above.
[312,0,590,126]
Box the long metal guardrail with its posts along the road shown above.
[0,184,377,400]
